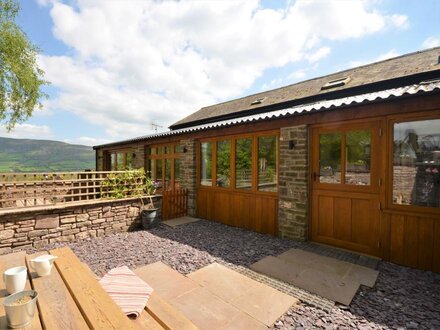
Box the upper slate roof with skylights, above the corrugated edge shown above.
[170,47,440,129]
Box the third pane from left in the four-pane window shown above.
[235,139,252,190]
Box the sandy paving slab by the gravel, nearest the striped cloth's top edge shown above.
[134,261,199,300]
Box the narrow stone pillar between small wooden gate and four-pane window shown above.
[180,140,197,216]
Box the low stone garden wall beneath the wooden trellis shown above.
[0,196,161,254]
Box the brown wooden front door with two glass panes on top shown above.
[311,121,384,255]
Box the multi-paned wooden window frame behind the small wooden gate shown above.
[145,142,182,190]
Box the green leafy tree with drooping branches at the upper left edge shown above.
[0,0,47,131]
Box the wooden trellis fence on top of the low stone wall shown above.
[0,171,148,210]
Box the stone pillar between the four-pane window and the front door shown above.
[278,125,309,241]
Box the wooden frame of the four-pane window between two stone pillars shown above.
[196,130,280,196]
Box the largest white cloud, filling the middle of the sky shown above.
[39,0,404,139]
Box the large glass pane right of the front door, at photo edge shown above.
[393,119,440,207]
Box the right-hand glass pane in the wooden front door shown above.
[345,130,371,185]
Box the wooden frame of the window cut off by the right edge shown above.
[386,109,440,216]
